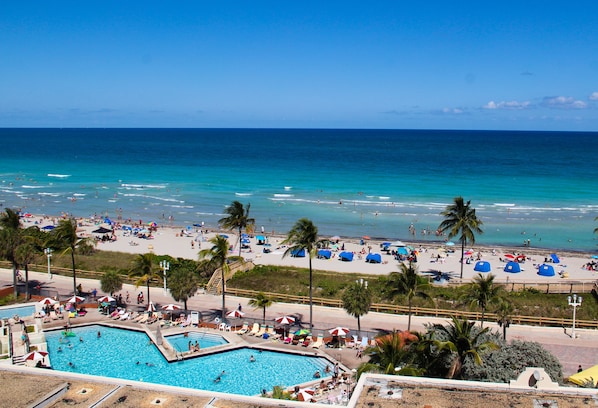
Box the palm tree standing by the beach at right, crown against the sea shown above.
[438,197,484,279]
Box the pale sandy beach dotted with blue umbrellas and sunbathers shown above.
[30,217,598,283]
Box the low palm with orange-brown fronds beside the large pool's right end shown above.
[358,331,424,376]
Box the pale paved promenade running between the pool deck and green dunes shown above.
[0,269,598,377]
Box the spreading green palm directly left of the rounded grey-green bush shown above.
[434,317,498,378]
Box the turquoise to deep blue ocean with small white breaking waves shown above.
[0,129,598,251]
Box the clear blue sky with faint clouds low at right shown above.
[0,0,598,131]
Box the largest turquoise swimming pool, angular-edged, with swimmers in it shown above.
[46,325,330,395]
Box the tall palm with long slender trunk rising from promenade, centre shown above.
[282,218,326,330]
